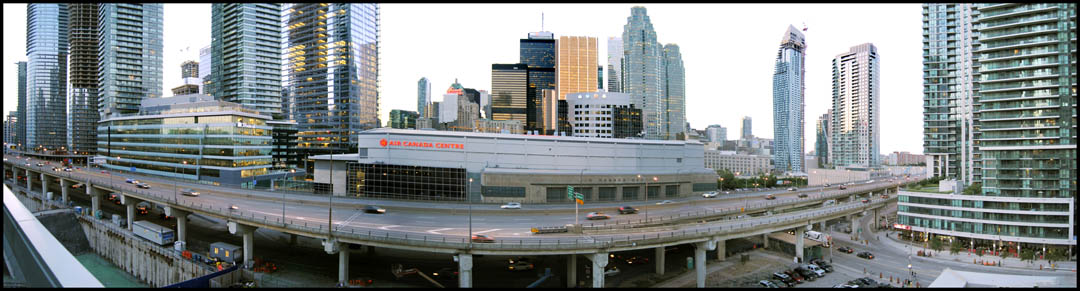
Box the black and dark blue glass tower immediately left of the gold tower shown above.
[518,31,557,131]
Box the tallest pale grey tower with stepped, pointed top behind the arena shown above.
[622,6,666,140]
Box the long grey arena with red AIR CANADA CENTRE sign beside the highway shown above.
[313,128,717,203]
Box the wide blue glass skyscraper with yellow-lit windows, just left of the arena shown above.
[282,3,380,173]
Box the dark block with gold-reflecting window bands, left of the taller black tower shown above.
[491,64,529,122]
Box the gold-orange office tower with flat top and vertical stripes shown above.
[555,36,597,100]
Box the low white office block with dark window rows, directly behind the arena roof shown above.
[566,92,642,138]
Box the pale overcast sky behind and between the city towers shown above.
[3,3,922,154]
